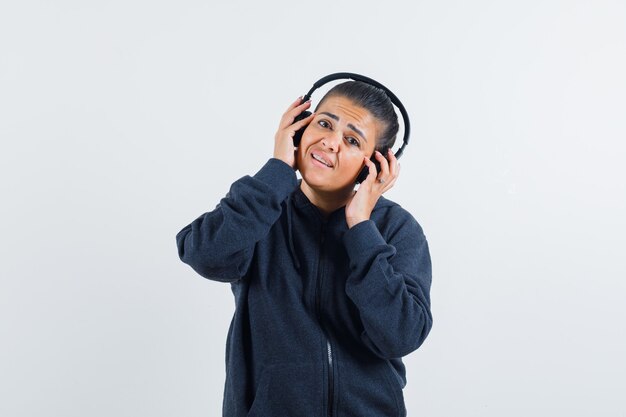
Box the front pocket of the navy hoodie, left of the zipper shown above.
[247,363,324,417]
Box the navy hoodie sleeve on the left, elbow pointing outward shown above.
[176,158,298,282]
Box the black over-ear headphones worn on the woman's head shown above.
[293,72,411,184]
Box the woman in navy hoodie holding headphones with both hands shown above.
[176,81,432,417]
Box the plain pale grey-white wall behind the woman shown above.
[0,0,626,417]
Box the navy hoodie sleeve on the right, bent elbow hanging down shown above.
[343,212,433,359]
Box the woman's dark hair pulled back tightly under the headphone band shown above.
[316,81,399,151]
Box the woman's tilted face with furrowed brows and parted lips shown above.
[296,96,382,192]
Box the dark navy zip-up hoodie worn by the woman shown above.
[176,158,432,417]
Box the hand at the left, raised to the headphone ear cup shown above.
[274,97,315,169]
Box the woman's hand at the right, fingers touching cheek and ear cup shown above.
[346,149,400,228]
